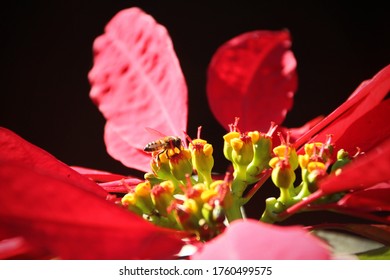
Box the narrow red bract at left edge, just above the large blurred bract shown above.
[0,127,107,198]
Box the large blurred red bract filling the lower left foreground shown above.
[0,161,182,259]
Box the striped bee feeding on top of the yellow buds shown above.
[144,128,183,159]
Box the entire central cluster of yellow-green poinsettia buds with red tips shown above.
[121,118,360,238]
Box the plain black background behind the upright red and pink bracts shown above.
[0,1,390,219]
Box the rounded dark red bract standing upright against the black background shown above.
[207,30,297,131]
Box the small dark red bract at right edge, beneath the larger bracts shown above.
[337,183,390,212]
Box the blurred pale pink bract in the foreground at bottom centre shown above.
[191,219,330,260]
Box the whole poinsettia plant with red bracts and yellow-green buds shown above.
[0,8,390,259]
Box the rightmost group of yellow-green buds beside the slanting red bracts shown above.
[261,135,359,223]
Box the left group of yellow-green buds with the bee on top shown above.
[121,128,230,240]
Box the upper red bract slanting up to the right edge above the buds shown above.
[295,65,390,154]
